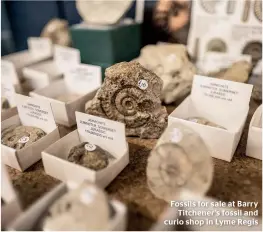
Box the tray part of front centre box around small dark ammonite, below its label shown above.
[42,130,129,188]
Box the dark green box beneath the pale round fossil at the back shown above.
[70,23,141,64]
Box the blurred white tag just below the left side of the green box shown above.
[54,45,80,73]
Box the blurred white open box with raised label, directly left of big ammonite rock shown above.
[30,64,101,127]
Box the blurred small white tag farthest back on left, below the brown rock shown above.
[28,37,53,57]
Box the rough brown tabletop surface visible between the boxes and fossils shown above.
[5,100,262,231]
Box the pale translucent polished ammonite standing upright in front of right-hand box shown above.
[146,124,213,202]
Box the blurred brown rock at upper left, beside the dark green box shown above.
[40,19,71,46]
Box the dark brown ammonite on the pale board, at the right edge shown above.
[242,41,262,65]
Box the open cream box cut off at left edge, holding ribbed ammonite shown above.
[1,95,60,171]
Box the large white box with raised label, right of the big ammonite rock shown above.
[168,75,252,162]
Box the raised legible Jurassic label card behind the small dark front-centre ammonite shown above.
[76,112,127,154]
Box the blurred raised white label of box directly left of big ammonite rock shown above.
[65,64,102,94]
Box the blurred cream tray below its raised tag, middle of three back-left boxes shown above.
[22,60,63,91]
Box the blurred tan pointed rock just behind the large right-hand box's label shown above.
[208,60,252,82]
